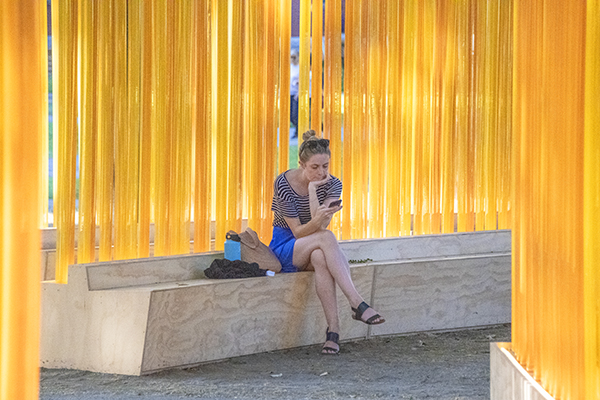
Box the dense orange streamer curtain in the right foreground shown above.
[510,1,598,399]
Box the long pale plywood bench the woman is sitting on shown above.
[41,231,510,375]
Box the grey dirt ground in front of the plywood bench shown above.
[40,324,510,400]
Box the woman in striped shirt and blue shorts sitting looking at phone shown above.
[269,130,385,354]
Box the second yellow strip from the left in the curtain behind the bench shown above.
[77,1,98,263]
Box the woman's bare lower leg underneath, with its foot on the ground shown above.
[310,249,340,352]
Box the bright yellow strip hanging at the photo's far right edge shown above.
[583,0,600,398]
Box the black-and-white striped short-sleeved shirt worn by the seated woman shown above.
[271,171,342,229]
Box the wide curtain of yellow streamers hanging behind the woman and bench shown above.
[45,0,516,276]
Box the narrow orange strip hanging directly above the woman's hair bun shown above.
[310,0,322,132]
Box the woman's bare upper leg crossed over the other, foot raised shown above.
[293,230,377,321]
